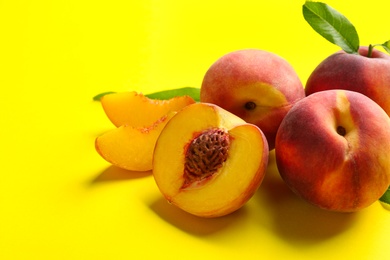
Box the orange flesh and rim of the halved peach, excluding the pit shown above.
[153,103,268,217]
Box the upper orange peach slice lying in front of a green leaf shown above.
[101,91,195,127]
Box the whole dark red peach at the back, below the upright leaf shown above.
[305,46,390,116]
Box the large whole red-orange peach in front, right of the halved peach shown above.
[275,90,390,212]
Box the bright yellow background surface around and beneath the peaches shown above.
[0,0,390,259]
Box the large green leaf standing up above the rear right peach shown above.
[302,1,359,54]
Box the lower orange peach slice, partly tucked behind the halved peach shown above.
[95,112,176,171]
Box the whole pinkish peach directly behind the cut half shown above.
[200,49,305,150]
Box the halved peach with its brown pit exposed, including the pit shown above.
[153,103,269,217]
